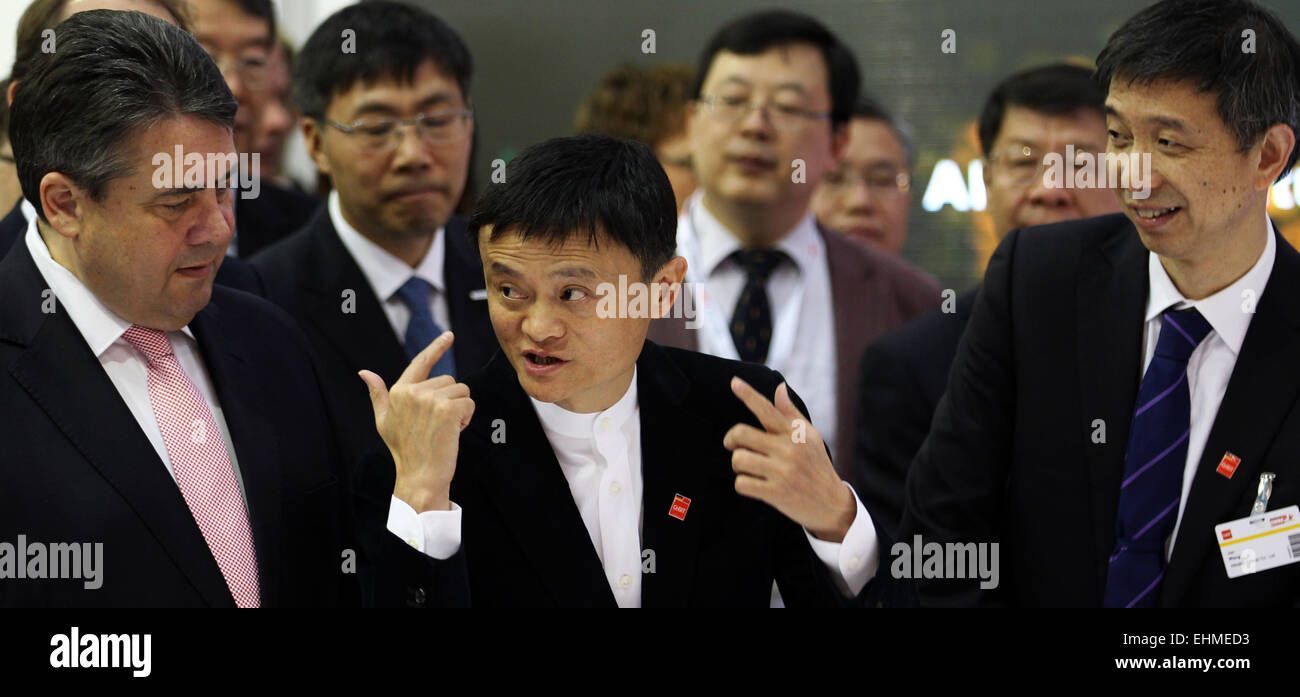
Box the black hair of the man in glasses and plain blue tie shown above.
[293,1,473,118]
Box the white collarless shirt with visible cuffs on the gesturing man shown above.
[389,372,879,607]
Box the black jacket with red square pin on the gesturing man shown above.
[431,341,888,607]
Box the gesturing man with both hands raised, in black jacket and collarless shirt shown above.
[363,135,888,607]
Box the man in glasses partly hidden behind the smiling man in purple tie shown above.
[854,64,1119,532]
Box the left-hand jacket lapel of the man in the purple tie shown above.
[1076,220,1149,603]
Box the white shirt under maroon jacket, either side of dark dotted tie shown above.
[677,191,839,453]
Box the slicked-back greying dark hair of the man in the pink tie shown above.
[9,10,238,222]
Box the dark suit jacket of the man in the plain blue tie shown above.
[252,207,498,463]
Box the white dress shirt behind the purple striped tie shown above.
[1141,225,1278,560]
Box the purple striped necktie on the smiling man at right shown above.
[1105,308,1210,607]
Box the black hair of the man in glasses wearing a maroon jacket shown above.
[692,9,862,127]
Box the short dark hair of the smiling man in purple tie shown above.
[1097,0,1300,178]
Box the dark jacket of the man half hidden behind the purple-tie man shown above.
[854,287,979,533]
